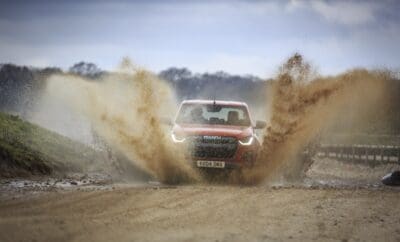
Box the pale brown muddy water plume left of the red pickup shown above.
[48,60,198,183]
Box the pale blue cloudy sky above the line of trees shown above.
[0,0,400,78]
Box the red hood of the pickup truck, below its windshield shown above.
[172,124,253,139]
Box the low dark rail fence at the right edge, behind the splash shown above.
[317,144,400,163]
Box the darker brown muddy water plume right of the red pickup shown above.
[242,54,388,183]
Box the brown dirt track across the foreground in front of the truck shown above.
[0,185,400,241]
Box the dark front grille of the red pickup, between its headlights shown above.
[190,135,238,158]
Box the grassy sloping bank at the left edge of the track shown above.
[0,113,104,177]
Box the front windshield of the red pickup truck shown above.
[176,104,250,126]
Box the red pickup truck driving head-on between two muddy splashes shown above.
[171,100,266,169]
